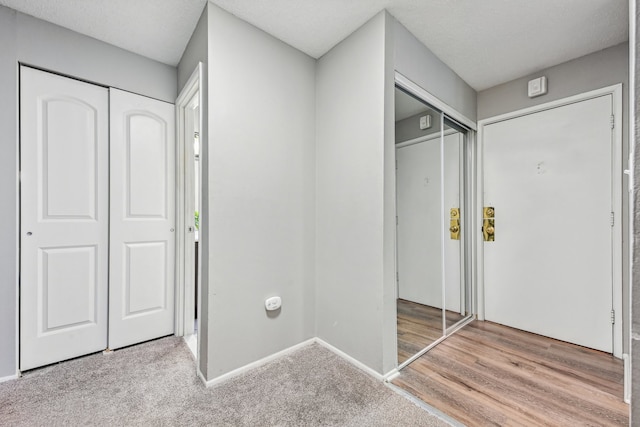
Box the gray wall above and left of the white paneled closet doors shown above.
[0,6,177,378]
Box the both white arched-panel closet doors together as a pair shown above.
[20,67,175,370]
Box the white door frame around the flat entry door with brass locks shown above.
[475,84,624,358]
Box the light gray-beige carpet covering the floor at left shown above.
[0,337,448,426]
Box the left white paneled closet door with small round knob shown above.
[20,67,109,370]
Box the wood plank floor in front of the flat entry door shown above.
[392,321,629,426]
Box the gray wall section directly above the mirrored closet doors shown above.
[394,19,476,121]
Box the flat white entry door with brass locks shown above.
[483,95,621,353]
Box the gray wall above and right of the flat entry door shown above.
[478,43,629,353]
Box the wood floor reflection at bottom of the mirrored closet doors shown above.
[397,299,463,364]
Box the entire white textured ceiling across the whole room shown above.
[0,0,629,90]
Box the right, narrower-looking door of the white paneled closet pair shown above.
[109,89,175,349]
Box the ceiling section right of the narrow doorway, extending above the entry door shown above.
[212,0,629,90]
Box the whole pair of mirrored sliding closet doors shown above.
[395,88,471,366]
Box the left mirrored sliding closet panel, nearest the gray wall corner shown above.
[395,88,444,364]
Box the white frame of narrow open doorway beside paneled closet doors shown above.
[175,62,204,350]
